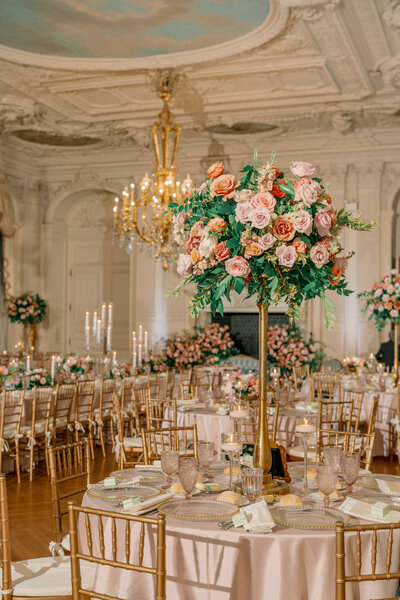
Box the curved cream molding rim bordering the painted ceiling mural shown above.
[0,0,290,72]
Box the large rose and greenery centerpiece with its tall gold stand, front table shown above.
[170,152,374,488]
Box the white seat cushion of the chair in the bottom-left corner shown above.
[11,556,96,598]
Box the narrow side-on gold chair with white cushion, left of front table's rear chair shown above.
[114,394,143,469]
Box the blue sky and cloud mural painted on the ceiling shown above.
[0,0,269,58]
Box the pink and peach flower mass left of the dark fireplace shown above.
[161,323,239,370]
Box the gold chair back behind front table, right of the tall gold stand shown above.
[317,428,375,471]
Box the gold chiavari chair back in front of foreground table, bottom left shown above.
[68,502,166,600]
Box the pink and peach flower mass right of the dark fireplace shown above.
[268,324,325,381]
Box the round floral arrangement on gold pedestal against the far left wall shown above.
[8,292,47,352]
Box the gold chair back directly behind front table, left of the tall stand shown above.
[142,425,197,465]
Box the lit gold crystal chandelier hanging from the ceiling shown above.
[113,70,192,270]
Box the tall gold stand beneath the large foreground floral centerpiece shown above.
[253,301,288,495]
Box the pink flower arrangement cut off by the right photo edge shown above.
[358,269,400,331]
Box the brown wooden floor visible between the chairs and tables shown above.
[7,448,400,560]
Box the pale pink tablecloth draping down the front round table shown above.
[80,486,400,600]
